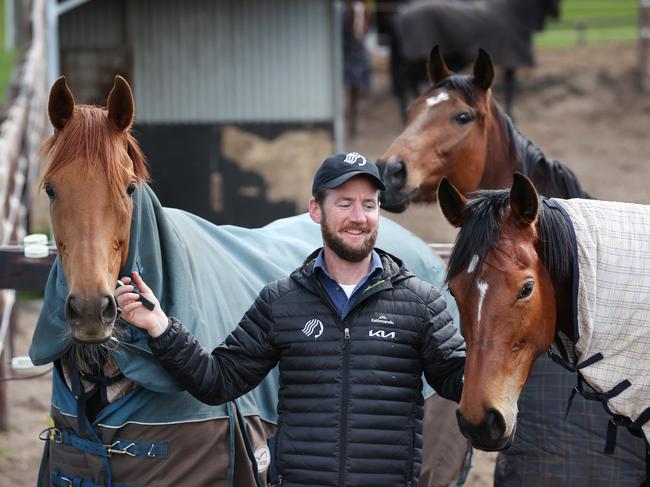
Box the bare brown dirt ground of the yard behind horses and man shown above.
[0,45,650,487]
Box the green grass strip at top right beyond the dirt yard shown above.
[535,0,639,48]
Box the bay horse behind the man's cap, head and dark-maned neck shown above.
[378,46,588,212]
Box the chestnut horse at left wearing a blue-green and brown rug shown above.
[30,76,467,487]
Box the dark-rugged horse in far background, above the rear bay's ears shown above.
[382,0,560,114]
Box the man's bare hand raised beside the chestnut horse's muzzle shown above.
[115,272,168,338]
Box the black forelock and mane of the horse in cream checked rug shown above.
[447,189,575,290]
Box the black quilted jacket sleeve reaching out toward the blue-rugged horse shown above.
[149,288,279,404]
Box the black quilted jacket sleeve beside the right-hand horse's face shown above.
[422,288,466,402]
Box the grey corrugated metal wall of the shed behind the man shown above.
[60,0,339,123]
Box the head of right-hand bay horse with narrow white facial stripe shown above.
[438,173,572,450]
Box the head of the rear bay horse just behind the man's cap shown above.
[377,46,496,212]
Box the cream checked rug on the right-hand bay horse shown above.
[558,200,650,446]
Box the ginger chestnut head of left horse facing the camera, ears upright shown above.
[42,76,148,343]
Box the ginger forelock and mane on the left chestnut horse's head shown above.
[41,105,149,207]
